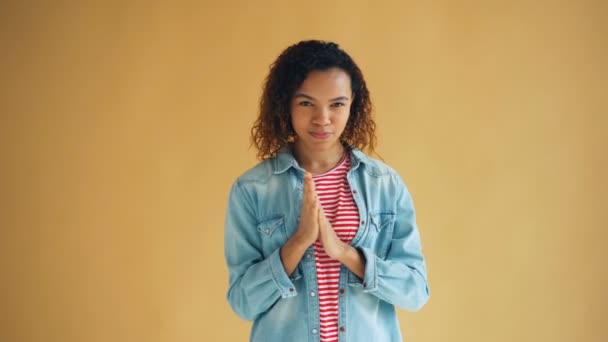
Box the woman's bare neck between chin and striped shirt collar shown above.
[294,141,346,174]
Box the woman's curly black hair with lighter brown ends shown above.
[251,40,376,160]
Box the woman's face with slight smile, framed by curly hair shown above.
[291,68,352,152]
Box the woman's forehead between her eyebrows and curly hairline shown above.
[296,68,352,99]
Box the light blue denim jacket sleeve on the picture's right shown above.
[352,176,430,311]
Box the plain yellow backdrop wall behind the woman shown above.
[0,0,608,342]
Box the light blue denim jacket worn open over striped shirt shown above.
[224,148,429,342]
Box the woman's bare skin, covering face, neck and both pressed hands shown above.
[281,68,365,278]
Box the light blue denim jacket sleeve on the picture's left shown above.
[224,180,297,320]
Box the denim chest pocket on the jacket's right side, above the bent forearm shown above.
[361,211,395,259]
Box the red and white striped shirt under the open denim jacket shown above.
[312,153,359,342]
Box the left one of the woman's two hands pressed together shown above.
[294,172,320,246]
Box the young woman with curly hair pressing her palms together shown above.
[225,40,429,342]
